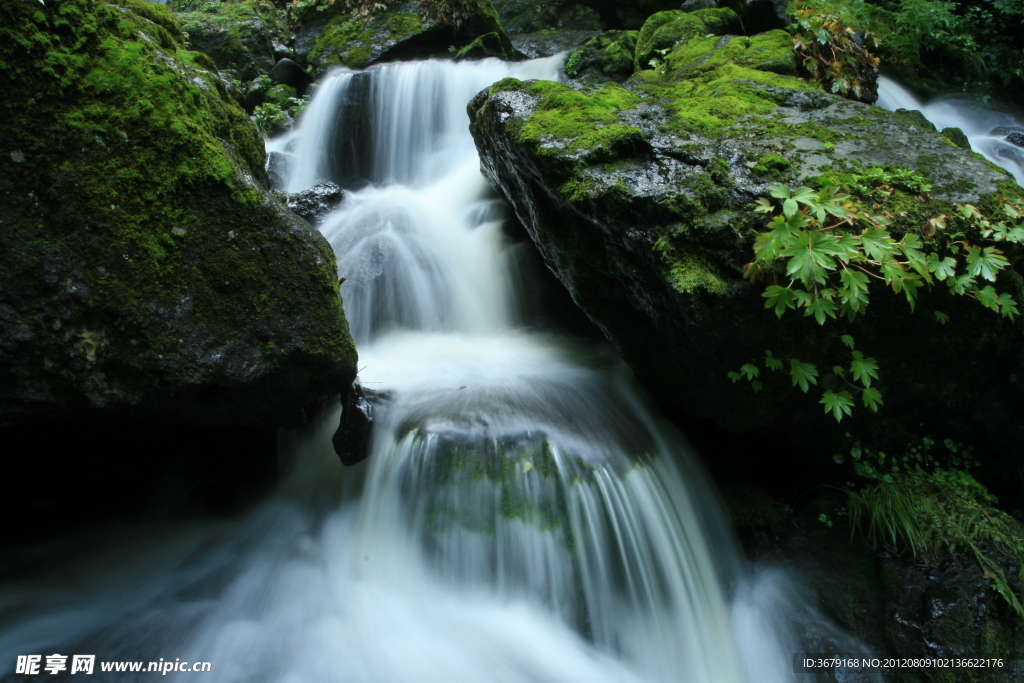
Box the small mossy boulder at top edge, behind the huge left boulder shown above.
[172,0,288,81]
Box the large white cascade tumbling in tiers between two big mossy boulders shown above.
[0,58,880,683]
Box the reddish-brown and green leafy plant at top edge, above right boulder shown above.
[788,0,879,101]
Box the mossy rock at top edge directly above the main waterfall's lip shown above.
[298,0,516,72]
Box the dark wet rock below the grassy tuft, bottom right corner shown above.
[737,485,1024,683]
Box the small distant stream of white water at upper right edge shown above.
[878,76,1024,184]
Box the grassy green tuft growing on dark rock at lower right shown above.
[836,437,1024,616]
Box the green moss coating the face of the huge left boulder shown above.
[0,0,354,413]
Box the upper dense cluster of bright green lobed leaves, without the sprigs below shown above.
[745,176,1024,325]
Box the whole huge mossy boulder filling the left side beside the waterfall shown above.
[0,0,355,426]
